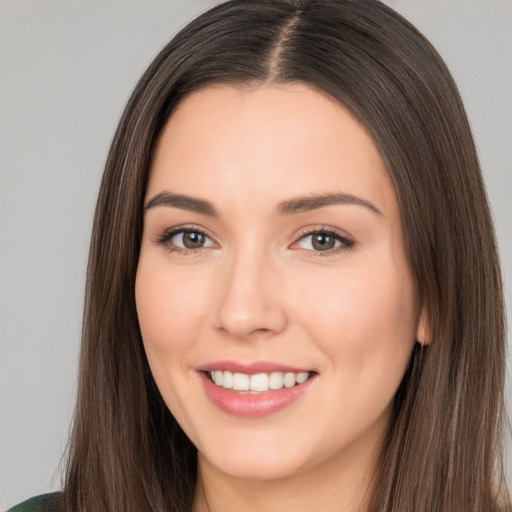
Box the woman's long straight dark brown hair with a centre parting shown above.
[63,0,508,512]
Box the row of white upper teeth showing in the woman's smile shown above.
[208,370,310,393]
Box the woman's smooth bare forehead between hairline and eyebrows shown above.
[147,84,396,218]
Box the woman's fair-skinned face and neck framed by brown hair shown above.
[136,84,420,512]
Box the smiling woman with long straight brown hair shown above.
[10,0,509,512]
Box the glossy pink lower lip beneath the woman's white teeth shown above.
[199,372,316,418]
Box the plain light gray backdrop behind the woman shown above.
[0,0,512,510]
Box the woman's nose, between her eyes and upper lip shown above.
[215,248,287,340]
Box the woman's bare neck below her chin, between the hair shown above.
[194,432,381,512]
